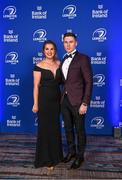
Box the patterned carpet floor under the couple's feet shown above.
[0,134,122,180]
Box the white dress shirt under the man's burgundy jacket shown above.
[62,49,76,79]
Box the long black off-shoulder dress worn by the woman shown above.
[34,65,63,168]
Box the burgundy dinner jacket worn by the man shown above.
[61,51,93,106]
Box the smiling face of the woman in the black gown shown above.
[44,44,56,59]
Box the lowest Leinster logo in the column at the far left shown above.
[7,94,20,107]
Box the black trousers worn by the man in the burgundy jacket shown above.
[61,94,86,157]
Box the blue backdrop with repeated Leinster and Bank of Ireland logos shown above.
[0,0,122,135]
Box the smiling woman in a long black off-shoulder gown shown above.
[32,40,63,169]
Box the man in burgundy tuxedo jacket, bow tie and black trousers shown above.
[61,33,92,169]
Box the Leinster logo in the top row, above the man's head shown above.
[62,4,77,19]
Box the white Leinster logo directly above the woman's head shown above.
[33,29,47,42]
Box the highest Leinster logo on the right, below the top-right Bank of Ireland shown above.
[92,28,107,42]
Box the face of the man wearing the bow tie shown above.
[64,36,77,53]
